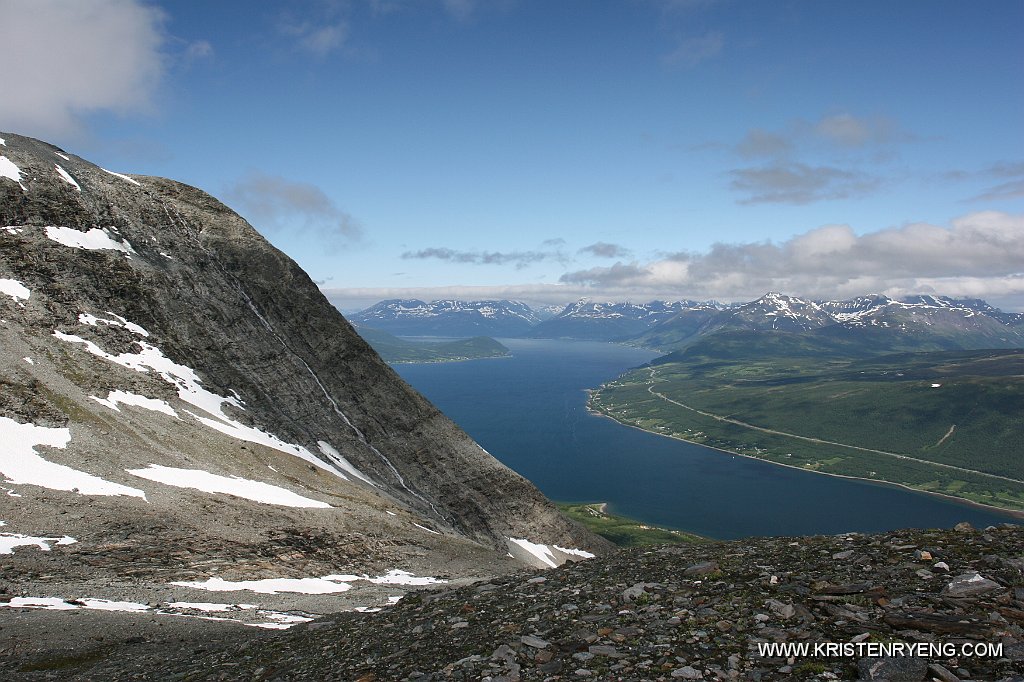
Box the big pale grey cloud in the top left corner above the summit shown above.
[0,0,165,137]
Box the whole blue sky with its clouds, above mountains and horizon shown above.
[0,0,1024,309]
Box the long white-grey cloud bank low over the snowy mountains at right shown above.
[561,211,1024,299]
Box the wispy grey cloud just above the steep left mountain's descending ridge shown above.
[224,172,362,247]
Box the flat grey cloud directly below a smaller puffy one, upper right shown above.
[729,162,882,204]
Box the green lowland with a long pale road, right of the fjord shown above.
[590,344,1024,509]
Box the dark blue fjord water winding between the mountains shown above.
[395,339,1015,539]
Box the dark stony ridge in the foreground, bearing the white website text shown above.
[2,524,1024,682]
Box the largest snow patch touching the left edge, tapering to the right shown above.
[0,417,145,500]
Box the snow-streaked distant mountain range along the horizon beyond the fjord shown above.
[351,292,1024,351]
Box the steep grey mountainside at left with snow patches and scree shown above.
[0,133,605,614]
